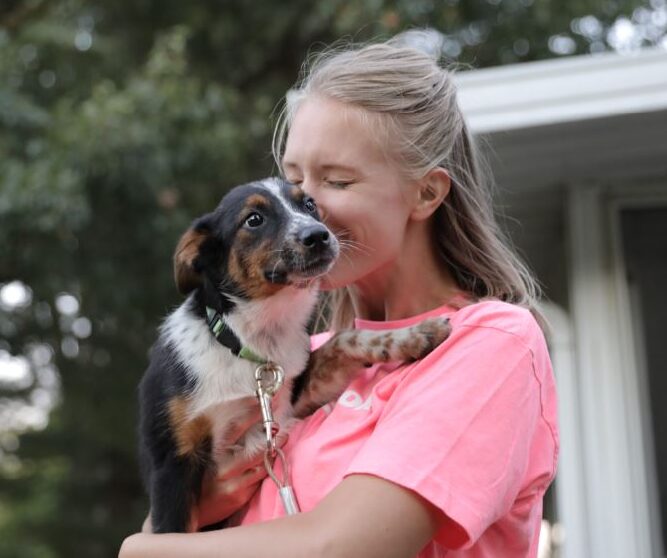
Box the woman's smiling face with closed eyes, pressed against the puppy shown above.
[283,97,414,289]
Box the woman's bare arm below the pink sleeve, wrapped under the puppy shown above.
[119,475,444,558]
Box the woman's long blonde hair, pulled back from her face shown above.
[273,32,539,329]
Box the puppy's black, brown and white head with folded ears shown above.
[174,178,339,299]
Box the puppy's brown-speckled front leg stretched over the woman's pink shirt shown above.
[292,318,451,417]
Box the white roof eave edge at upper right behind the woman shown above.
[455,48,667,134]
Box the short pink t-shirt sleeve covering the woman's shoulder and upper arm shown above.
[346,312,555,548]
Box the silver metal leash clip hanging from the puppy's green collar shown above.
[255,362,299,515]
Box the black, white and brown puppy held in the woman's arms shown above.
[140,178,449,533]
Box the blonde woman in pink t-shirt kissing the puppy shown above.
[121,32,558,558]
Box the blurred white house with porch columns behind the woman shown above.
[457,49,667,558]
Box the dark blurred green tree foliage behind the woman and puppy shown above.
[0,0,664,558]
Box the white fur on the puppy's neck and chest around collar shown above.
[161,287,317,455]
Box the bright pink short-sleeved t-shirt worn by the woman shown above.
[242,301,558,558]
